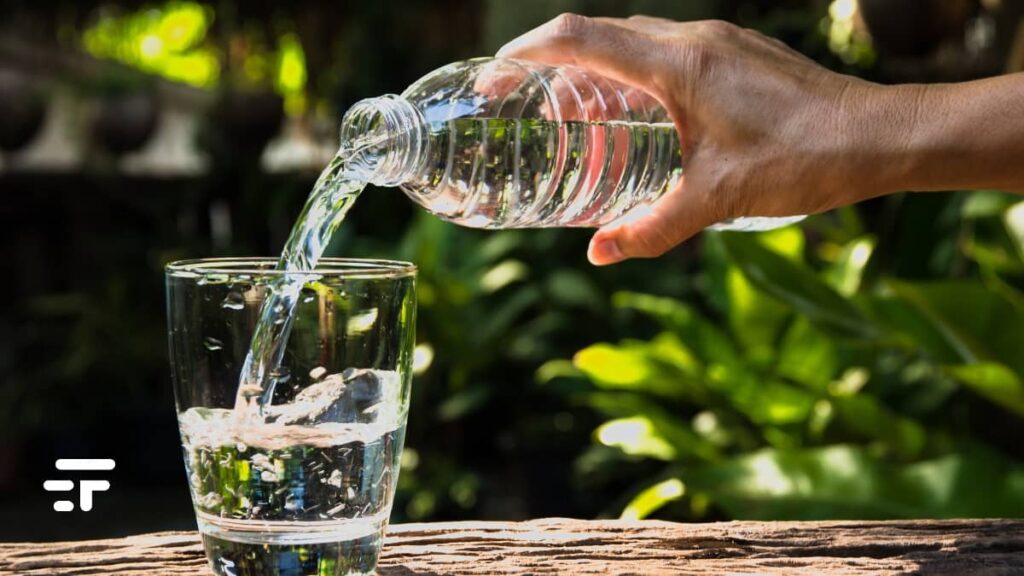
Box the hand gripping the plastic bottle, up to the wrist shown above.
[498,14,890,264]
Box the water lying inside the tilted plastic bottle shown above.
[407,118,682,229]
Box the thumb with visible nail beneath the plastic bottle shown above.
[587,179,716,265]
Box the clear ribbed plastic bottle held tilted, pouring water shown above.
[341,58,803,230]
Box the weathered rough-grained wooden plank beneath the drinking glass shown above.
[0,519,1024,576]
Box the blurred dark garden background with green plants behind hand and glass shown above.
[0,0,1024,540]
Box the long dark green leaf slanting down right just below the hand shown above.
[722,233,874,336]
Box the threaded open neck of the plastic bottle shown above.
[341,94,429,186]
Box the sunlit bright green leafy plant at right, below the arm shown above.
[538,193,1024,520]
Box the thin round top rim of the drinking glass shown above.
[164,256,416,279]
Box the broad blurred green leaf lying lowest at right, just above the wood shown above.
[683,445,1024,520]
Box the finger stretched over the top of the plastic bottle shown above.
[498,14,664,96]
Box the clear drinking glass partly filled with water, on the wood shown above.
[166,258,416,576]
